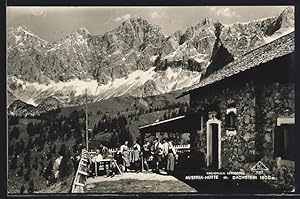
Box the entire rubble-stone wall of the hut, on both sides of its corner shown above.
[190,82,295,189]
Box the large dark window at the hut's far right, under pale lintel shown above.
[274,120,296,161]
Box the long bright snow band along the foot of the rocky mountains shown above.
[12,67,201,106]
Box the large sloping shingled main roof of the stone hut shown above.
[179,31,295,97]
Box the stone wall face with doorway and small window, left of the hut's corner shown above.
[190,80,256,170]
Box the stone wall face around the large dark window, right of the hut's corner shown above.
[261,83,295,190]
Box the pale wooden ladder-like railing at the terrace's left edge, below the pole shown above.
[71,149,88,193]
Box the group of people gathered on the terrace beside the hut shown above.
[91,138,178,176]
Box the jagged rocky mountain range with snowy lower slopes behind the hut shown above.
[7,8,294,113]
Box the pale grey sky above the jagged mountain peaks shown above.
[7,6,292,41]
